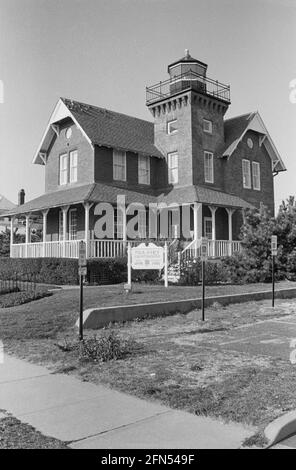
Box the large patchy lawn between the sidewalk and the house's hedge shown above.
[0,283,296,436]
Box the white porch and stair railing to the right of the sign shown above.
[182,239,241,259]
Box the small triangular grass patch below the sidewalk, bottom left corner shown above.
[0,414,68,450]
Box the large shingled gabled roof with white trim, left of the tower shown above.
[33,98,164,165]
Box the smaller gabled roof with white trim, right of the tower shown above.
[222,111,286,172]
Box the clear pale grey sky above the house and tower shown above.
[0,0,296,206]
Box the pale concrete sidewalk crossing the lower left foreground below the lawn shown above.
[0,355,253,449]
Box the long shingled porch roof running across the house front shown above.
[5,183,253,216]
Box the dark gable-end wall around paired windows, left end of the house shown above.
[45,124,94,192]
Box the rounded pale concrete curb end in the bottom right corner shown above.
[264,411,296,447]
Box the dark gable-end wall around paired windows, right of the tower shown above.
[224,131,274,214]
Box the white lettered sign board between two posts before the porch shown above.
[131,243,165,269]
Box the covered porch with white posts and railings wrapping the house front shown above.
[10,198,242,259]
